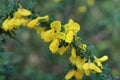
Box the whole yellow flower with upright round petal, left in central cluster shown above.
[41,21,65,42]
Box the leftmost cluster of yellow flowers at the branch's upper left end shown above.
[2,6,49,31]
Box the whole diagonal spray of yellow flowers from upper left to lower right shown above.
[2,6,108,80]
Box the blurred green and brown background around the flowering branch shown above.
[0,0,120,80]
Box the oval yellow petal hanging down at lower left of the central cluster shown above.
[49,39,59,53]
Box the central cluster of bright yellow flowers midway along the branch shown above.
[37,19,80,55]
